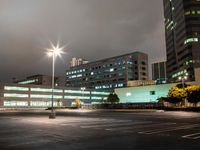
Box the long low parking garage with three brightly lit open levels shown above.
[0,84,110,108]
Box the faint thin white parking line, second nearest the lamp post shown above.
[105,122,176,131]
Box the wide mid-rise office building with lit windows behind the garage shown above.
[66,52,148,89]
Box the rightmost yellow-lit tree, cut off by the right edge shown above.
[186,85,200,106]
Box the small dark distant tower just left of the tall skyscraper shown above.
[151,61,167,84]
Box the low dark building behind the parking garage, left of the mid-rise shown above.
[14,75,65,86]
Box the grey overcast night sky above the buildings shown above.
[0,0,165,82]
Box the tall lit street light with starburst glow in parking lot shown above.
[47,43,64,119]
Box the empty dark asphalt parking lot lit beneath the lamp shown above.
[0,110,200,150]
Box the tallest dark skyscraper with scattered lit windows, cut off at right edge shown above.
[163,0,200,82]
